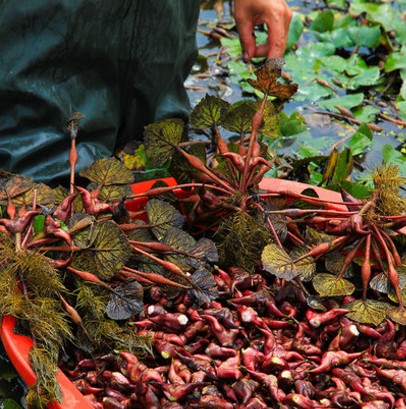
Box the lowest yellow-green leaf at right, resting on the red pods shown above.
[344,300,391,325]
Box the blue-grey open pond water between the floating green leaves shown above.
[190,0,406,181]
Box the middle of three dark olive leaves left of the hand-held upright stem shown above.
[190,95,230,129]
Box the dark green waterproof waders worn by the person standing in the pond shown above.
[0,0,199,184]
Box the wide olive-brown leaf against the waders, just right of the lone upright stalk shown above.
[79,157,134,186]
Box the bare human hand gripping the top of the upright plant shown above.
[234,0,292,62]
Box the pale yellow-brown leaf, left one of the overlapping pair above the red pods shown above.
[261,243,301,281]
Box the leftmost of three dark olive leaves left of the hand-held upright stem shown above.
[144,118,184,167]
